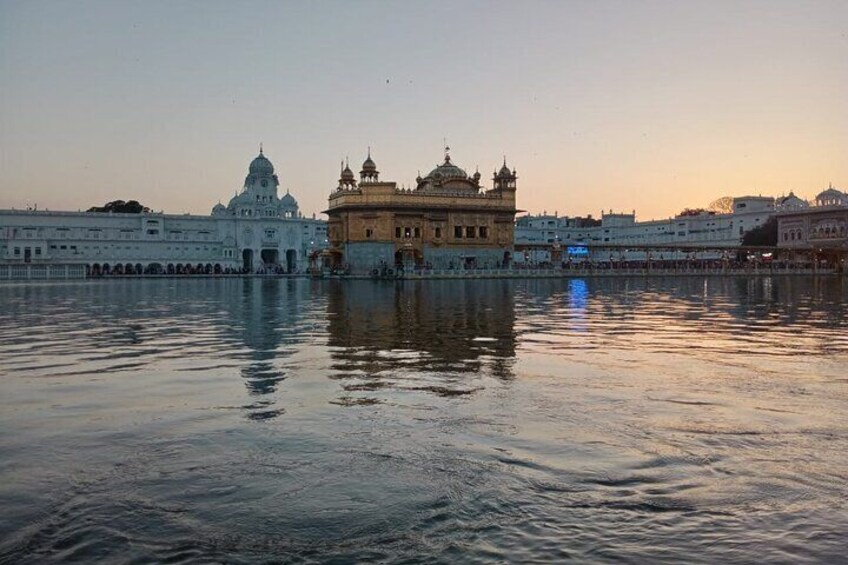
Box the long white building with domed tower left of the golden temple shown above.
[0,149,326,274]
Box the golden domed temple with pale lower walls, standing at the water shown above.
[325,148,518,273]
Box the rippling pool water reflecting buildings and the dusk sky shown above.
[0,278,848,563]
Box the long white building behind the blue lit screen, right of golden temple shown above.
[515,196,775,263]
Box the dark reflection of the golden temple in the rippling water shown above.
[327,280,515,377]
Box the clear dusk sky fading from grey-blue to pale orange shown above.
[0,0,848,219]
